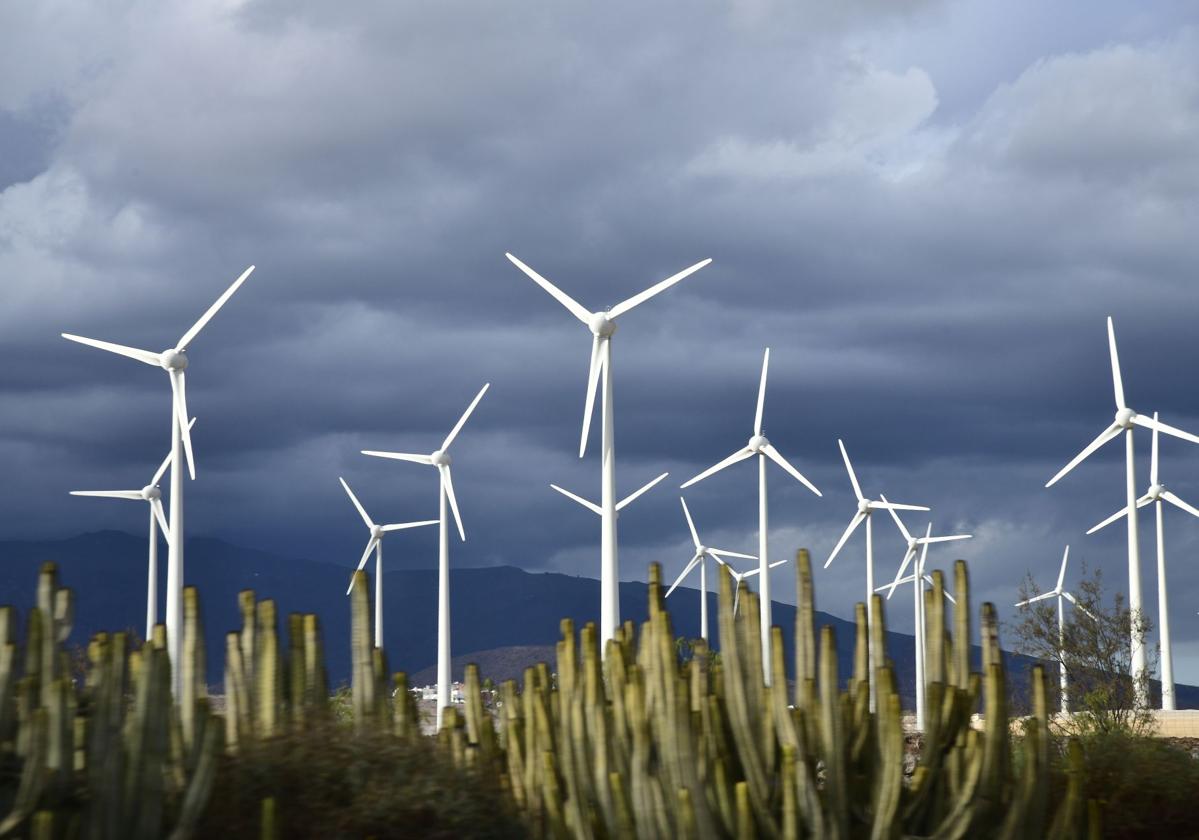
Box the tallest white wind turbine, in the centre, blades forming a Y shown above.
[505,254,711,651]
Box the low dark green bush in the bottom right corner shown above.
[1083,733,1199,839]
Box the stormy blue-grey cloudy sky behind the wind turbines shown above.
[0,0,1199,683]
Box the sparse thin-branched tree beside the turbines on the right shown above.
[1011,563,1155,736]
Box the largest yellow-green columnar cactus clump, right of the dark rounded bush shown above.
[441,551,1095,840]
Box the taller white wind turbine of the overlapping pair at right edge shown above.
[1046,316,1199,708]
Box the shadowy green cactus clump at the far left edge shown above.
[0,563,222,840]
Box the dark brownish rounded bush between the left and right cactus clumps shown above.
[195,723,528,840]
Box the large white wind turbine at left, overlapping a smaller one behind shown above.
[62,266,254,695]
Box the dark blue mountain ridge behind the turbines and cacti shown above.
[0,531,1199,708]
